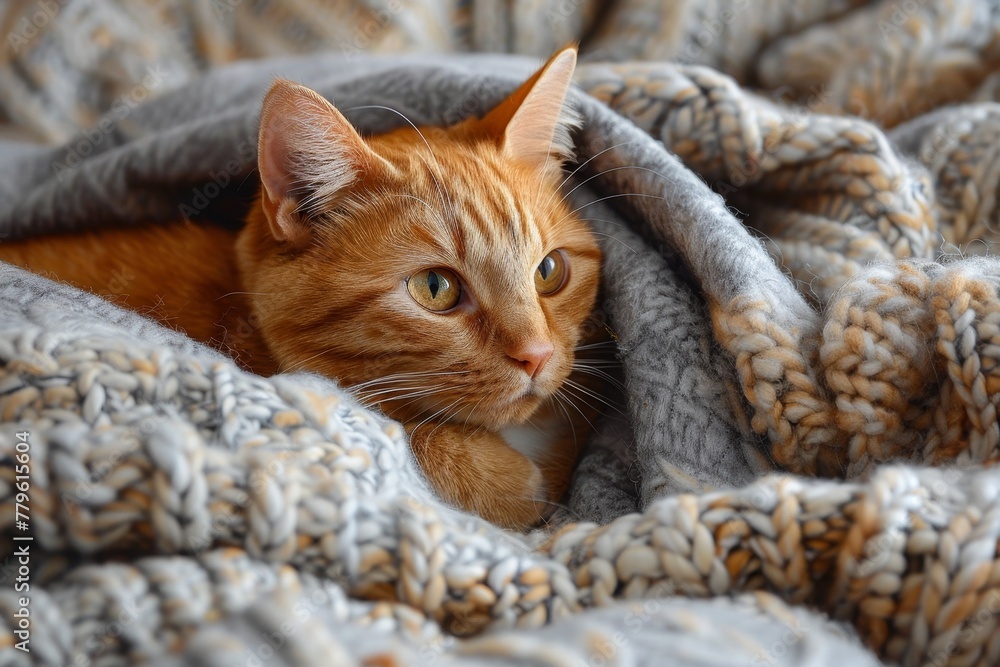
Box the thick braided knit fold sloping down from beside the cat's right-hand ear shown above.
[578,64,938,264]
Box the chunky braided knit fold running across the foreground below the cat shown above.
[7,336,1000,664]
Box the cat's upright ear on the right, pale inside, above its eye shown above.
[482,46,580,179]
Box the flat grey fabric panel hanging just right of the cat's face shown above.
[582,205,768,506]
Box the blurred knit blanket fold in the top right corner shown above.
[756,0,1000,127]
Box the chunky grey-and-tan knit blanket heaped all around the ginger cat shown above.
[0,0,1000,666]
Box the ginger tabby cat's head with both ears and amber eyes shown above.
[239,49,600,428]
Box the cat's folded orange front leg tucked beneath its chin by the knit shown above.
[406,423,555,529]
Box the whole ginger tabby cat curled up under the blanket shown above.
[0,48,603,529]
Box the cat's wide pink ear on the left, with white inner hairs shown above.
[257,79,383,245]
